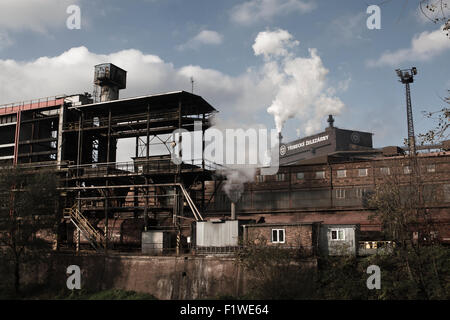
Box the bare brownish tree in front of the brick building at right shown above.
[369,157,448,299]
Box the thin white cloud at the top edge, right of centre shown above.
[231,0,316,25]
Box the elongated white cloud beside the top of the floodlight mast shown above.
[367,26,450,67]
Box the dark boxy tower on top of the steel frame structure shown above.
[93,63,127,102]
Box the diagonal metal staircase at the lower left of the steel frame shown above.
[64,205,105,251]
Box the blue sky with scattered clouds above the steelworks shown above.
[0,0,450,156]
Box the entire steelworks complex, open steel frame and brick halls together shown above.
[0,64,450,254]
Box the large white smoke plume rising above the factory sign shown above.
[253,29,344,134]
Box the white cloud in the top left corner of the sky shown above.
[0,0,80,33]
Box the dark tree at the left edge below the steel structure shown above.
[0,168,58,294]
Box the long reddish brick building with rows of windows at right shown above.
[207,119,450,243]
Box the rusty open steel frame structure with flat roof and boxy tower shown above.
[0,64,216,250]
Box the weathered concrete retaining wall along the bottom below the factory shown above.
[18,253,317,300]
